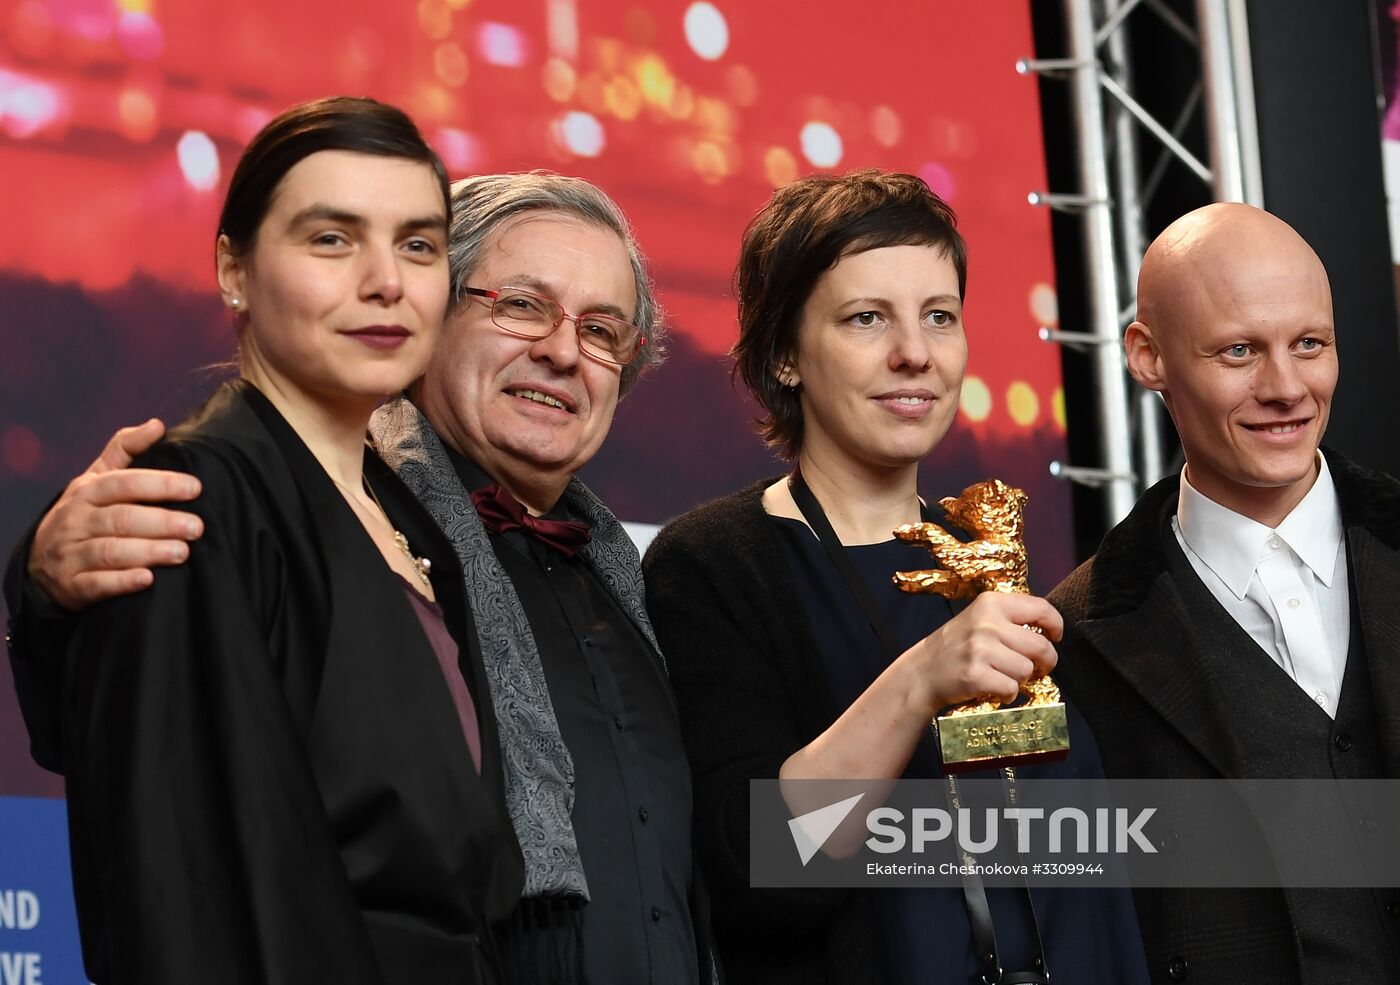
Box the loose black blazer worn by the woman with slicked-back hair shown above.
[50,383,522,985]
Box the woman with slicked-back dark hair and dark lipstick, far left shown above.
[63,98,521,985]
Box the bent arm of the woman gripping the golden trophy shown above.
[645,503,1063,878]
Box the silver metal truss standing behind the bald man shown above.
[1016,0,1263,527]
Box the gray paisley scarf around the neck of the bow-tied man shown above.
[370,400,664,900]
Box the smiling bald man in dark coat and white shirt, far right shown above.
[1050,204,1400,985]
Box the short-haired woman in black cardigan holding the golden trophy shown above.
[645,171,1147,985]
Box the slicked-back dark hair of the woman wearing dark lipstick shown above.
[218,95,452,253]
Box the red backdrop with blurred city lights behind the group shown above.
[0,0,1071,795]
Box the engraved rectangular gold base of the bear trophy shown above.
[934,702,1070,772]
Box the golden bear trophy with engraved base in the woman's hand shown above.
[895,479,1070,772]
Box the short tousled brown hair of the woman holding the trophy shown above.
[731,168,967,459]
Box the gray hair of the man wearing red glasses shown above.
[448,171,666,395]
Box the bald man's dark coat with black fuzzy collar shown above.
[1049,451,1400,985]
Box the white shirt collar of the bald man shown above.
[1176,452,1343,599]
